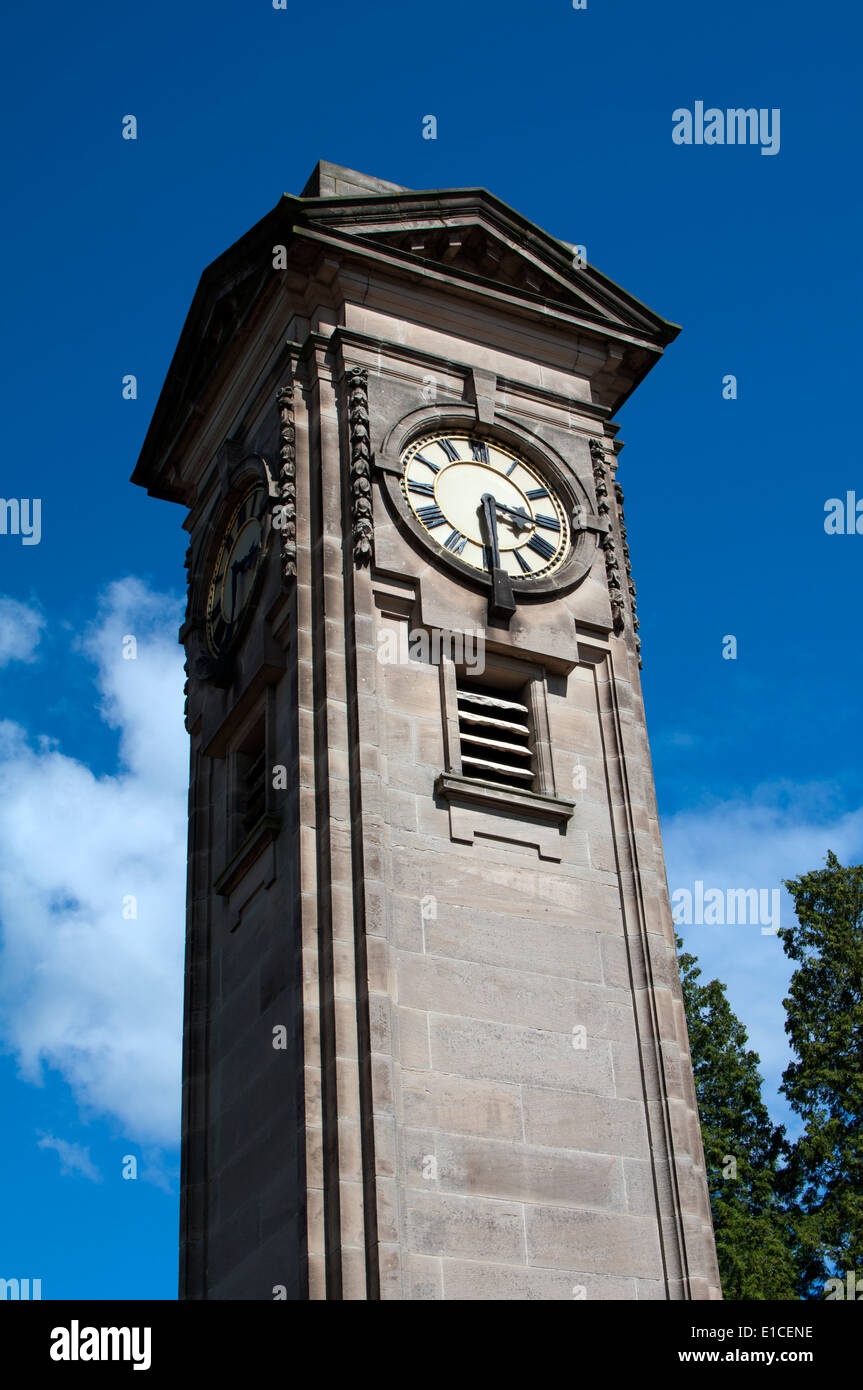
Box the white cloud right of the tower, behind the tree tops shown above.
[663,783,863,1119]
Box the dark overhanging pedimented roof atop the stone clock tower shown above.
[132,160,680,500]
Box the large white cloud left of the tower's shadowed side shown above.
[0,580,188,1145]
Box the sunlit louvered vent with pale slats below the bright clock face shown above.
[457,678,534,791]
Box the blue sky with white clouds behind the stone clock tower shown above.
[0,0,863,1298]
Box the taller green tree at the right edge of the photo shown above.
[778,851,863,1298]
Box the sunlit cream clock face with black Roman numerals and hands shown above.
[402,430,570,580]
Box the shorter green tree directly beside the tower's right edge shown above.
[677,937,798,1300]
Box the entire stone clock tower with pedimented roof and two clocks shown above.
[133,164,720,1300]
